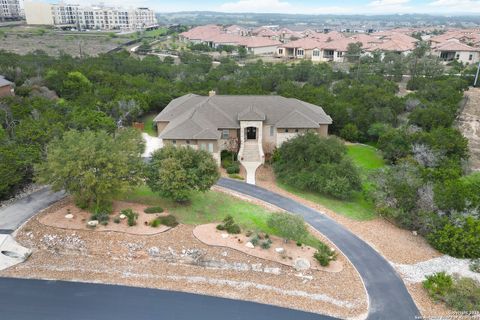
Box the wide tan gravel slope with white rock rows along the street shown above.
[0,198,368,318]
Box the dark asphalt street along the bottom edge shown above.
[0,278,334,320]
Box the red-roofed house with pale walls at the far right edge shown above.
[432,39,480,64]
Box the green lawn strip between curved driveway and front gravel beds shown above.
[118,186,321,247]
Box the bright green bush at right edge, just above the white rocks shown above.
[427,217,480,259]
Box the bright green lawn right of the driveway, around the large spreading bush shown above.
[277,144,385,221]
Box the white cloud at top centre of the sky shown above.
[218,0,293,13]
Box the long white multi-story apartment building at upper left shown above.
[24,0,157,30]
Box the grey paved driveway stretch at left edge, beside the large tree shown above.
[0,187,65,233]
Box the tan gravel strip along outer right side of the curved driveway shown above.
[257,166,442,264]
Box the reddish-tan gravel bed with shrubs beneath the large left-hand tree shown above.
[38,198,170,235]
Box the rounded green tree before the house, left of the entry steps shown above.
[146,146,220,202]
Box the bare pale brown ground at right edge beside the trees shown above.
[457,88,480,171]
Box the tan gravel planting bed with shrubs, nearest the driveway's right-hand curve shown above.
[193,223,343,272]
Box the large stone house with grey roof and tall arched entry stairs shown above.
[154,91,332,182]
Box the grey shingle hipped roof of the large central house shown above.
[154,94,332,139]
